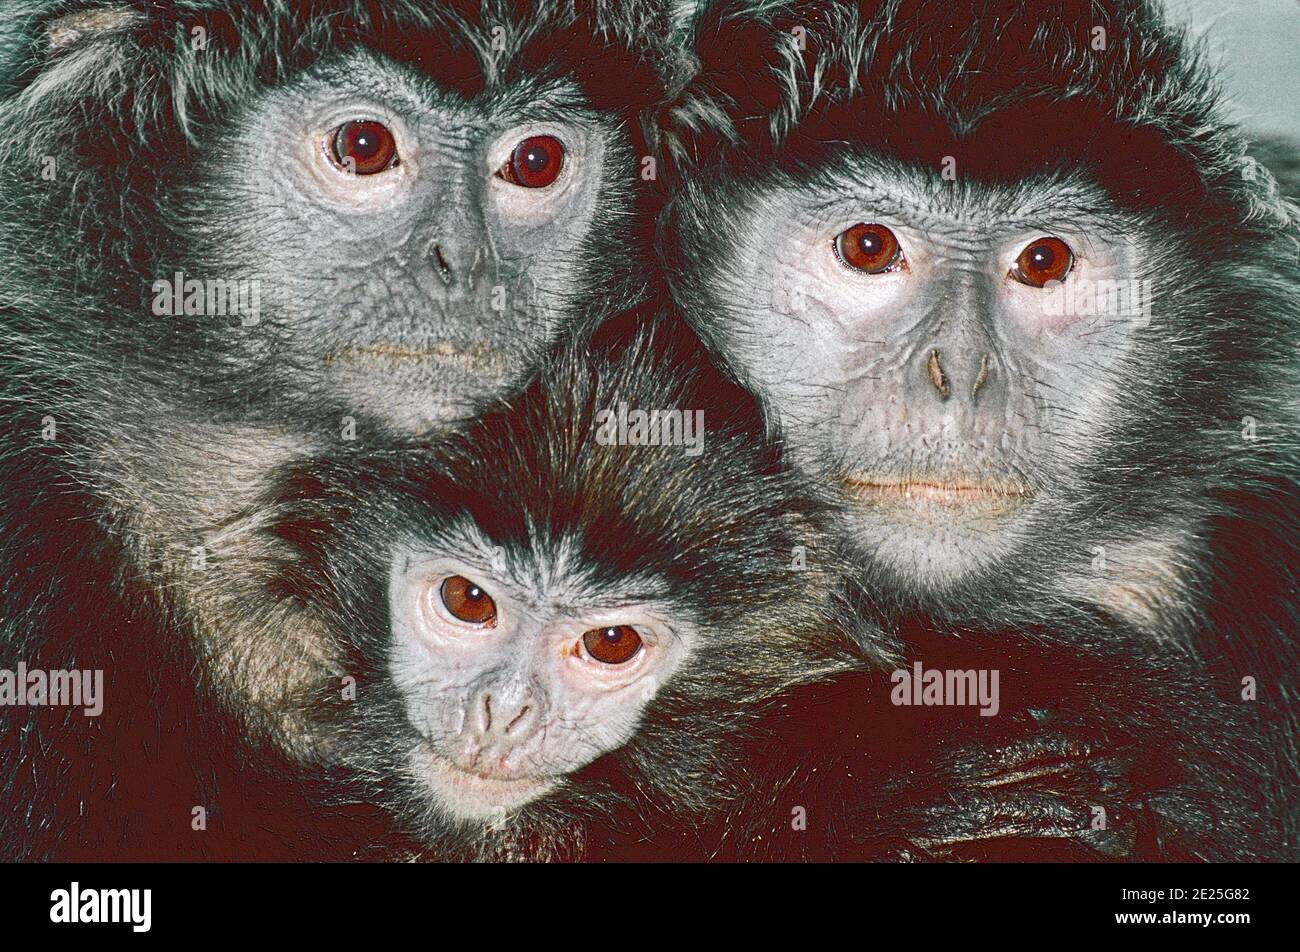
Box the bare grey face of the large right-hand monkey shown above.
[683,159,1153,597]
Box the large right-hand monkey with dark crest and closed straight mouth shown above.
[660,0,1300,860]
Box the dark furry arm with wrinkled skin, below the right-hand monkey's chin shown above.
[722,624,1274,861]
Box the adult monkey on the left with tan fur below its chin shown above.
[0,0,681,858]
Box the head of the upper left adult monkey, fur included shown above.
[9,0,666,433]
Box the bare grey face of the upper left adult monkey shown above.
[194,51,629,432]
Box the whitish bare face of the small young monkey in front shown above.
[389,530,692,821]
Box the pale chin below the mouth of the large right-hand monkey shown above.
[844,476,1032,598]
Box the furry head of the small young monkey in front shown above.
[258,310,878,854]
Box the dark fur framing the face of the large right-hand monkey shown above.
[664,0,1300,858]
